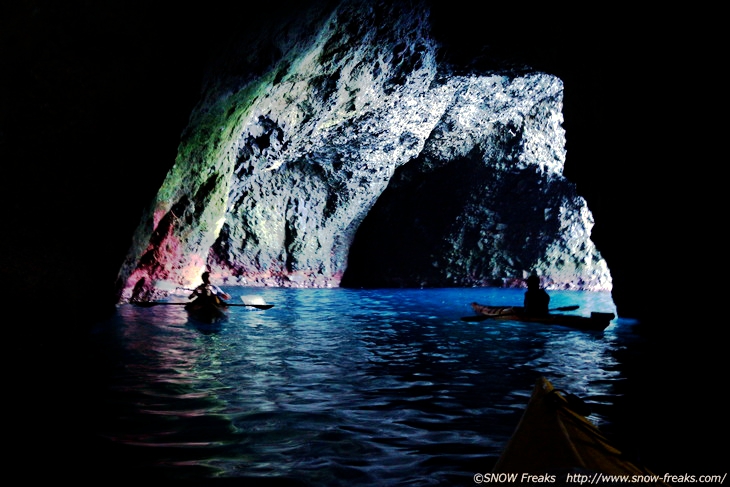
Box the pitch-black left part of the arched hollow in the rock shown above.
[341,155,478,287]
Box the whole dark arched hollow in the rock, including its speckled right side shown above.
[341,152,575,288]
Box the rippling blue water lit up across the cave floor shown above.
[89,287,630,485]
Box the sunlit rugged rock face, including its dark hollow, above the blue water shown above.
[119,1,611,300]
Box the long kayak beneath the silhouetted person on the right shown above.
[462,303,616,331]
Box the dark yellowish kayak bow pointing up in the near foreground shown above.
[492,377,667,485]
